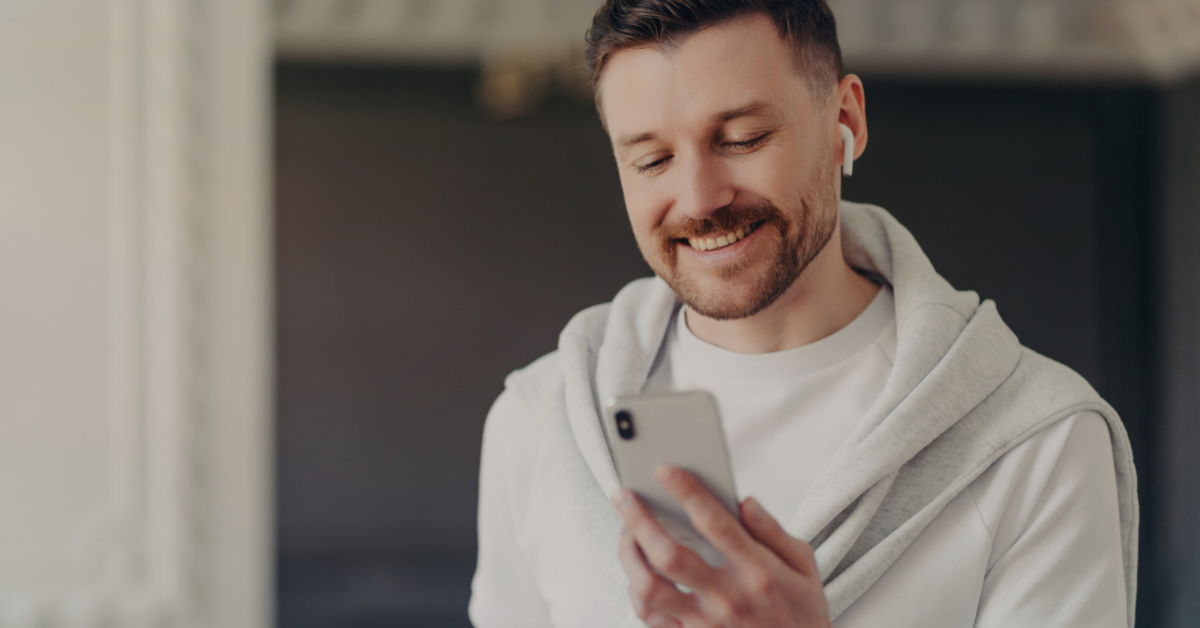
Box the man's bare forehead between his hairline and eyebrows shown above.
[598,14,811,137]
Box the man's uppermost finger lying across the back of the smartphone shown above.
[654,465,756,561]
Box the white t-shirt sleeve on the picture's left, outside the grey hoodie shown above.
[468,390,551,628]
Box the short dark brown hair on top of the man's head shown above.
[586,0,845,100]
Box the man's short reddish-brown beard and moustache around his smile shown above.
[642,159,838,321]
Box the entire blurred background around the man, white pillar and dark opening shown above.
[0,0,1200,628]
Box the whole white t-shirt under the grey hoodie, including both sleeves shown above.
[469,289,1126,628]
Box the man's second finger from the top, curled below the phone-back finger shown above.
[613,489,715,588]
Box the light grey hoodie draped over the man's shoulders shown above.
[506,202,1138,626]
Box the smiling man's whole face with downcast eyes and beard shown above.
[599,16,838,319]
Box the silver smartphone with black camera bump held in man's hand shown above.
[605,391,738,567]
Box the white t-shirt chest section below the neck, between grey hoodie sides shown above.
[643,288,896,525]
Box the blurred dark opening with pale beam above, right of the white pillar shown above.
[274,0,1200,628]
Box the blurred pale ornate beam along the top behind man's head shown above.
[275,0,1200,83]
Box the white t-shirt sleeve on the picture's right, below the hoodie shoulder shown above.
[976,412,1127,628]
